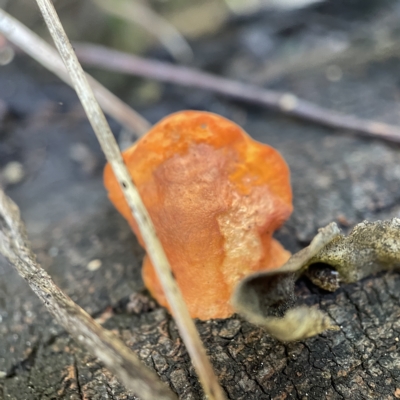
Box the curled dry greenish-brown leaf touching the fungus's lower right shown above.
[232,218,400,342]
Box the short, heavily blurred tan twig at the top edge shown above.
[93,0,193,61]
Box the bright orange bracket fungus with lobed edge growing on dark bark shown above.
[104,111,292,319]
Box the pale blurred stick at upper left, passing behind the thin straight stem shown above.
[0,9,151,135]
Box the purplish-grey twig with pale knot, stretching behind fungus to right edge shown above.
[74,43,400,143]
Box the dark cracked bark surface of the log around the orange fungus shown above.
[0,2,400,400]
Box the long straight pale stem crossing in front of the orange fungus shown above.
[36,0,225,400]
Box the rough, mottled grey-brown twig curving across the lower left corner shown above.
[0,190,176,400]
